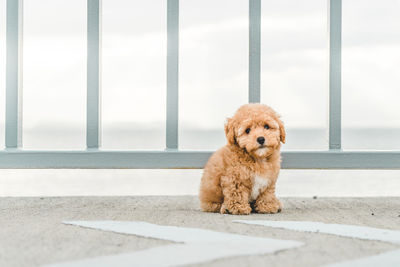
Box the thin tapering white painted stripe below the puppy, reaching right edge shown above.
[233,220,400,244]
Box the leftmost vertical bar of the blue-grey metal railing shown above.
[5,0,22,148]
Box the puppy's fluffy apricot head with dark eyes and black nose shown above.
[225,104,286,158]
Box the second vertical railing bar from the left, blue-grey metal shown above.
[86,0,101,149]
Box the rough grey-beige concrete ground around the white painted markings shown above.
[0,196,400,266]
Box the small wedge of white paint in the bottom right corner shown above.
[325,250,400,267]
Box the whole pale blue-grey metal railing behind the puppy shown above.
[0,0,400,169]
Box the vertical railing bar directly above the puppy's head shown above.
[249,0,261,103]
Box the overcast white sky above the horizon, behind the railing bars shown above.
[0,0,400,151]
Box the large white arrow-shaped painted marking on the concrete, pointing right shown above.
[44,221,303,267]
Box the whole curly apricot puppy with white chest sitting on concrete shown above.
[199,104,286,217]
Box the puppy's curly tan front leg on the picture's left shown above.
[220,176,251,215]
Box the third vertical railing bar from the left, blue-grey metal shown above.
[166,0,179,149]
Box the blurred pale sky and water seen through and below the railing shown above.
[0,0,400,196]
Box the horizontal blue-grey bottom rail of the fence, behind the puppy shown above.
[0,150,400,169]
